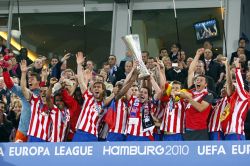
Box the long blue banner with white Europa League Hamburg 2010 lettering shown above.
[0,141,250,166]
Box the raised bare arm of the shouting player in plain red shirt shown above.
[187,48,204,88]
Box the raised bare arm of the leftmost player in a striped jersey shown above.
[20,60,31,100]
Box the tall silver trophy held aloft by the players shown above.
[122,34,150,78]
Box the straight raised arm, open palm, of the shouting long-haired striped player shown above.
[76,52,87,93]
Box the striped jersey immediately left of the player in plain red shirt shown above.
[160,100,185,133]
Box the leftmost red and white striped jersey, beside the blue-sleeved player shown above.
[28,94,51,141]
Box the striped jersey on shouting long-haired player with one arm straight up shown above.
[76,90,104,137]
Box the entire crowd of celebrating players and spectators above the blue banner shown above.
[0,38,250,142]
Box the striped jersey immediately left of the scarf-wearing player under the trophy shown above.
[109,98,128,134]
